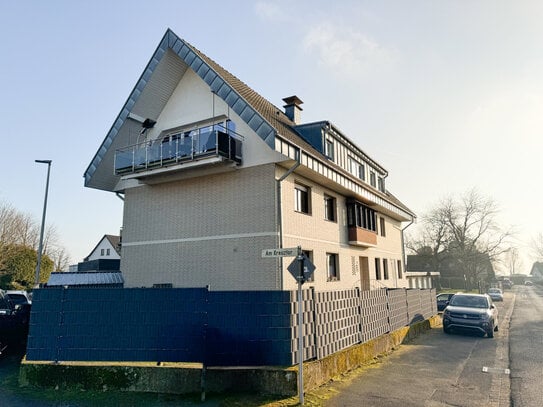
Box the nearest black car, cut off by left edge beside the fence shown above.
[0,290,30,354]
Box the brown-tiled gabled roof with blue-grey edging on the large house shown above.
[84,29,415,217]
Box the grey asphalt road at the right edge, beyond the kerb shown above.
[510,286,543,407]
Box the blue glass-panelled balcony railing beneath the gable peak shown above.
[115,125,241,175]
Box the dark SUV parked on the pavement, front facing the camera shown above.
[443,293,498,338]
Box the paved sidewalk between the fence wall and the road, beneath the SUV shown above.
[321,292,516,407]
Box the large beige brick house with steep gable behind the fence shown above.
[85,30,415,290]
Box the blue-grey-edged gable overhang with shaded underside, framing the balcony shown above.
[84,29,276,191]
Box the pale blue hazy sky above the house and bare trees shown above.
[0,0,543,272]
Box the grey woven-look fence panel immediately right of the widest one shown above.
[360,289,390,342]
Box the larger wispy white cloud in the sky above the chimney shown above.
[303,22,394,77]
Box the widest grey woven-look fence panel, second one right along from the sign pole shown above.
[315,289,360,359]
